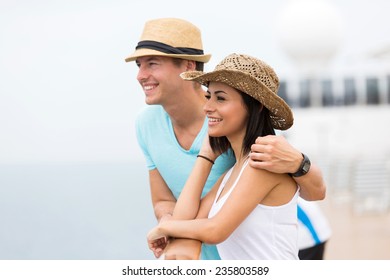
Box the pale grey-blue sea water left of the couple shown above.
[0,162,155,260]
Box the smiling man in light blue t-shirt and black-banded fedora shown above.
[125,18,326,259]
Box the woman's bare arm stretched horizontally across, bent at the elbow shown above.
[148,166,286,244]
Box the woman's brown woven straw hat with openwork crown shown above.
[181,54,294,130]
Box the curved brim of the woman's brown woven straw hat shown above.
[180,70,294,130]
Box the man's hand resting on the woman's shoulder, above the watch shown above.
[249,135,303,173]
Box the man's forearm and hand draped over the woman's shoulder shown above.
[249,135,326,201]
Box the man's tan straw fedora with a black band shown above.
[125,18,211,62]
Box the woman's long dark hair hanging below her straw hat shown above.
[210,91,275,156]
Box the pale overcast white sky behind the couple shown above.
[0,0,390,163]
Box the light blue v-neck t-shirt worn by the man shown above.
[136,105,235,259]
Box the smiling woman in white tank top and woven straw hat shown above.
[148,54,299,259]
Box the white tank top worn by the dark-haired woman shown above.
[209,160,299,260]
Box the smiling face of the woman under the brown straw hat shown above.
[203,82,248,141]
